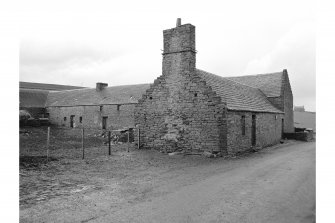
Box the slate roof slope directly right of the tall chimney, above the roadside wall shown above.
[197,69,283,113]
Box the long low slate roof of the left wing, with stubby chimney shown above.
[47,84,150,107]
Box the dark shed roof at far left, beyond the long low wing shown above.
[19,89,48,108]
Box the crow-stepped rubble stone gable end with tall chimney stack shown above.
[135,24,226,154]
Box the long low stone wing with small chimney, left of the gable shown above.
[46,83,149,129]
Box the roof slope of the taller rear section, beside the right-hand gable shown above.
[227,72,283,97]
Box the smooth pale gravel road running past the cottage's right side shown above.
[92,143,315,223]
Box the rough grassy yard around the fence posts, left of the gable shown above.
[20,127,211,210]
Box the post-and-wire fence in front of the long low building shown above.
[20,126,134,165]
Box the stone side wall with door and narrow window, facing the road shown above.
[227,111,283,154]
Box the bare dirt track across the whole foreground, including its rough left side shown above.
[20,143,315,222]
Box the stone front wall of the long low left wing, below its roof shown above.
[47,104,135,129]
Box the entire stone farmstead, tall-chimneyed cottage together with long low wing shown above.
[21,19,294,154]
